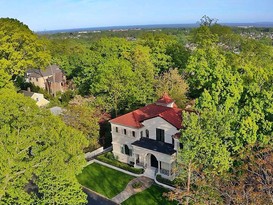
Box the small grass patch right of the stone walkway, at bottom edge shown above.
[122,185,177,205]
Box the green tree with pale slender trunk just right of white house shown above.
[170,110,233,204]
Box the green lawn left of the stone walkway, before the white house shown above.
[77,163,134,199]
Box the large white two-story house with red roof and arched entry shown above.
[110,94,182,180]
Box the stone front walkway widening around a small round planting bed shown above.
[111,176,154,204]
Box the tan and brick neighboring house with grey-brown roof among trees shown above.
[26,65,66,95]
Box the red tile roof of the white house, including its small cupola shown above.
[110,94,182,129]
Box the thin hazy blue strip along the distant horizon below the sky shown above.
[36,22,273,34]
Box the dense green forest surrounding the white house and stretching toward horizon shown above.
[0,16,273,204]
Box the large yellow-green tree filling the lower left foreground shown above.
[0,89,88,204]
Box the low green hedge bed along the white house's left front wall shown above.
[97,152,144,174]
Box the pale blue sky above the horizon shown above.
[0,0,273,31]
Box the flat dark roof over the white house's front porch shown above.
[132,137,176,155]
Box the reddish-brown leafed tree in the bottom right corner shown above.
[217,144,273,204]
